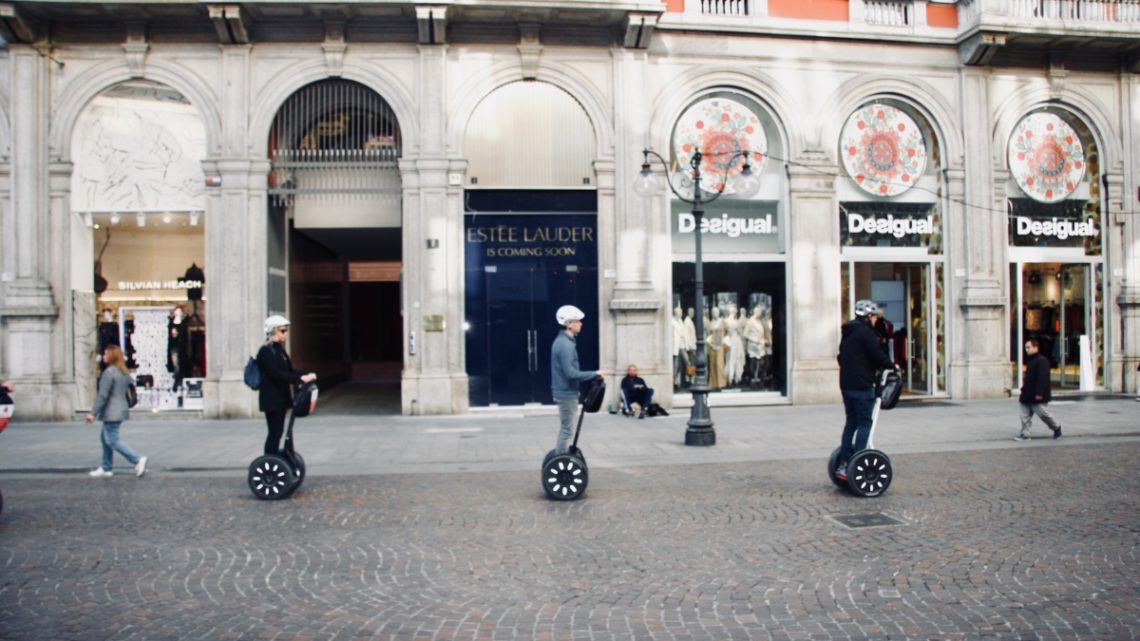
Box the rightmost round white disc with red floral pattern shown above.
[1009,112,1085,203]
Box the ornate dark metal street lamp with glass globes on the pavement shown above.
[634,149,760,445]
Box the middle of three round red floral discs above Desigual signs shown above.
[840,103,927,196]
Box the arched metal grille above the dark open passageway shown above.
[269,79,400,204]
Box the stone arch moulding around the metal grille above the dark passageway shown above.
[250,60,420,157]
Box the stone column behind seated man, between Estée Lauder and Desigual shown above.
[594,49,673,396]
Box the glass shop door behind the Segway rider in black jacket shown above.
[842,262,937,395]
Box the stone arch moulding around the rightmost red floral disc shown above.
[991,87,1124,173]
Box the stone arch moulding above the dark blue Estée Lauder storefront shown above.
[446,63,613,159]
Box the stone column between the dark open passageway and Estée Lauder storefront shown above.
[400,44,469,415]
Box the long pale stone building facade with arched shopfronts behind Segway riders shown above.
[0,0,1140,419]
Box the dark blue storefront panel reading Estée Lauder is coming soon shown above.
[464,193,599,406]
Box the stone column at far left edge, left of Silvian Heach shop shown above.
[0,43,60,419]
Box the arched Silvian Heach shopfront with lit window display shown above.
[71,80,209,411]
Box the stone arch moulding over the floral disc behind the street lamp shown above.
[650,68,805,161]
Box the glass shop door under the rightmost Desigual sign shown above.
[1010,262,1097,389]
